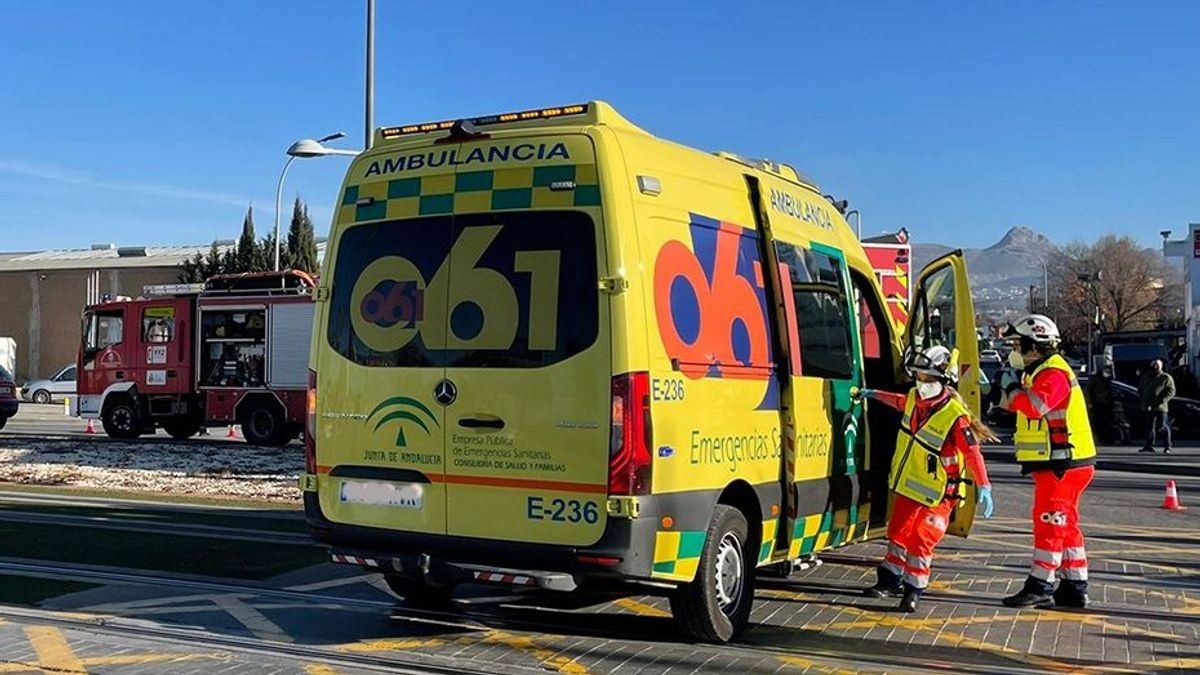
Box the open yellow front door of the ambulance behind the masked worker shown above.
[901,250,982,537]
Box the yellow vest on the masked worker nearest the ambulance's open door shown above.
[888,392,967,506]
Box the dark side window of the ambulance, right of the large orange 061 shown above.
[775,241,854,380]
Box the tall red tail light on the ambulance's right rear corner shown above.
[608,372,652,495]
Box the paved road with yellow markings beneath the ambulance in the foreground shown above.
[0,439,1200,674]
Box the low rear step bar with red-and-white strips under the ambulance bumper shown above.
[330,550,578,592]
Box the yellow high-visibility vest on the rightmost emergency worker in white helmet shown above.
[1013,354,1096,464]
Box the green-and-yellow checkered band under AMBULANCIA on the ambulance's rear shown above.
[340,165,600,222]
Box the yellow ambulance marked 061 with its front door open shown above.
[301,102,979,641]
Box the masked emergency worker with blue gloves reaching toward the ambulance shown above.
[856,345,996,613]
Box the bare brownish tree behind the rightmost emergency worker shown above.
[1050,234,1182,342]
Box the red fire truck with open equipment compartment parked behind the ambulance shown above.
[71,271,316,446]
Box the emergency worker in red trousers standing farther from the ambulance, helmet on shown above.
[1003,315,1096,609]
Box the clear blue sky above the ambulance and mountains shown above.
[0,0,1200,251]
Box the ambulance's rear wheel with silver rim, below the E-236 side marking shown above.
[671,504,756,644]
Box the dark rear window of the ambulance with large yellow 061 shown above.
[326,210,600,368]
